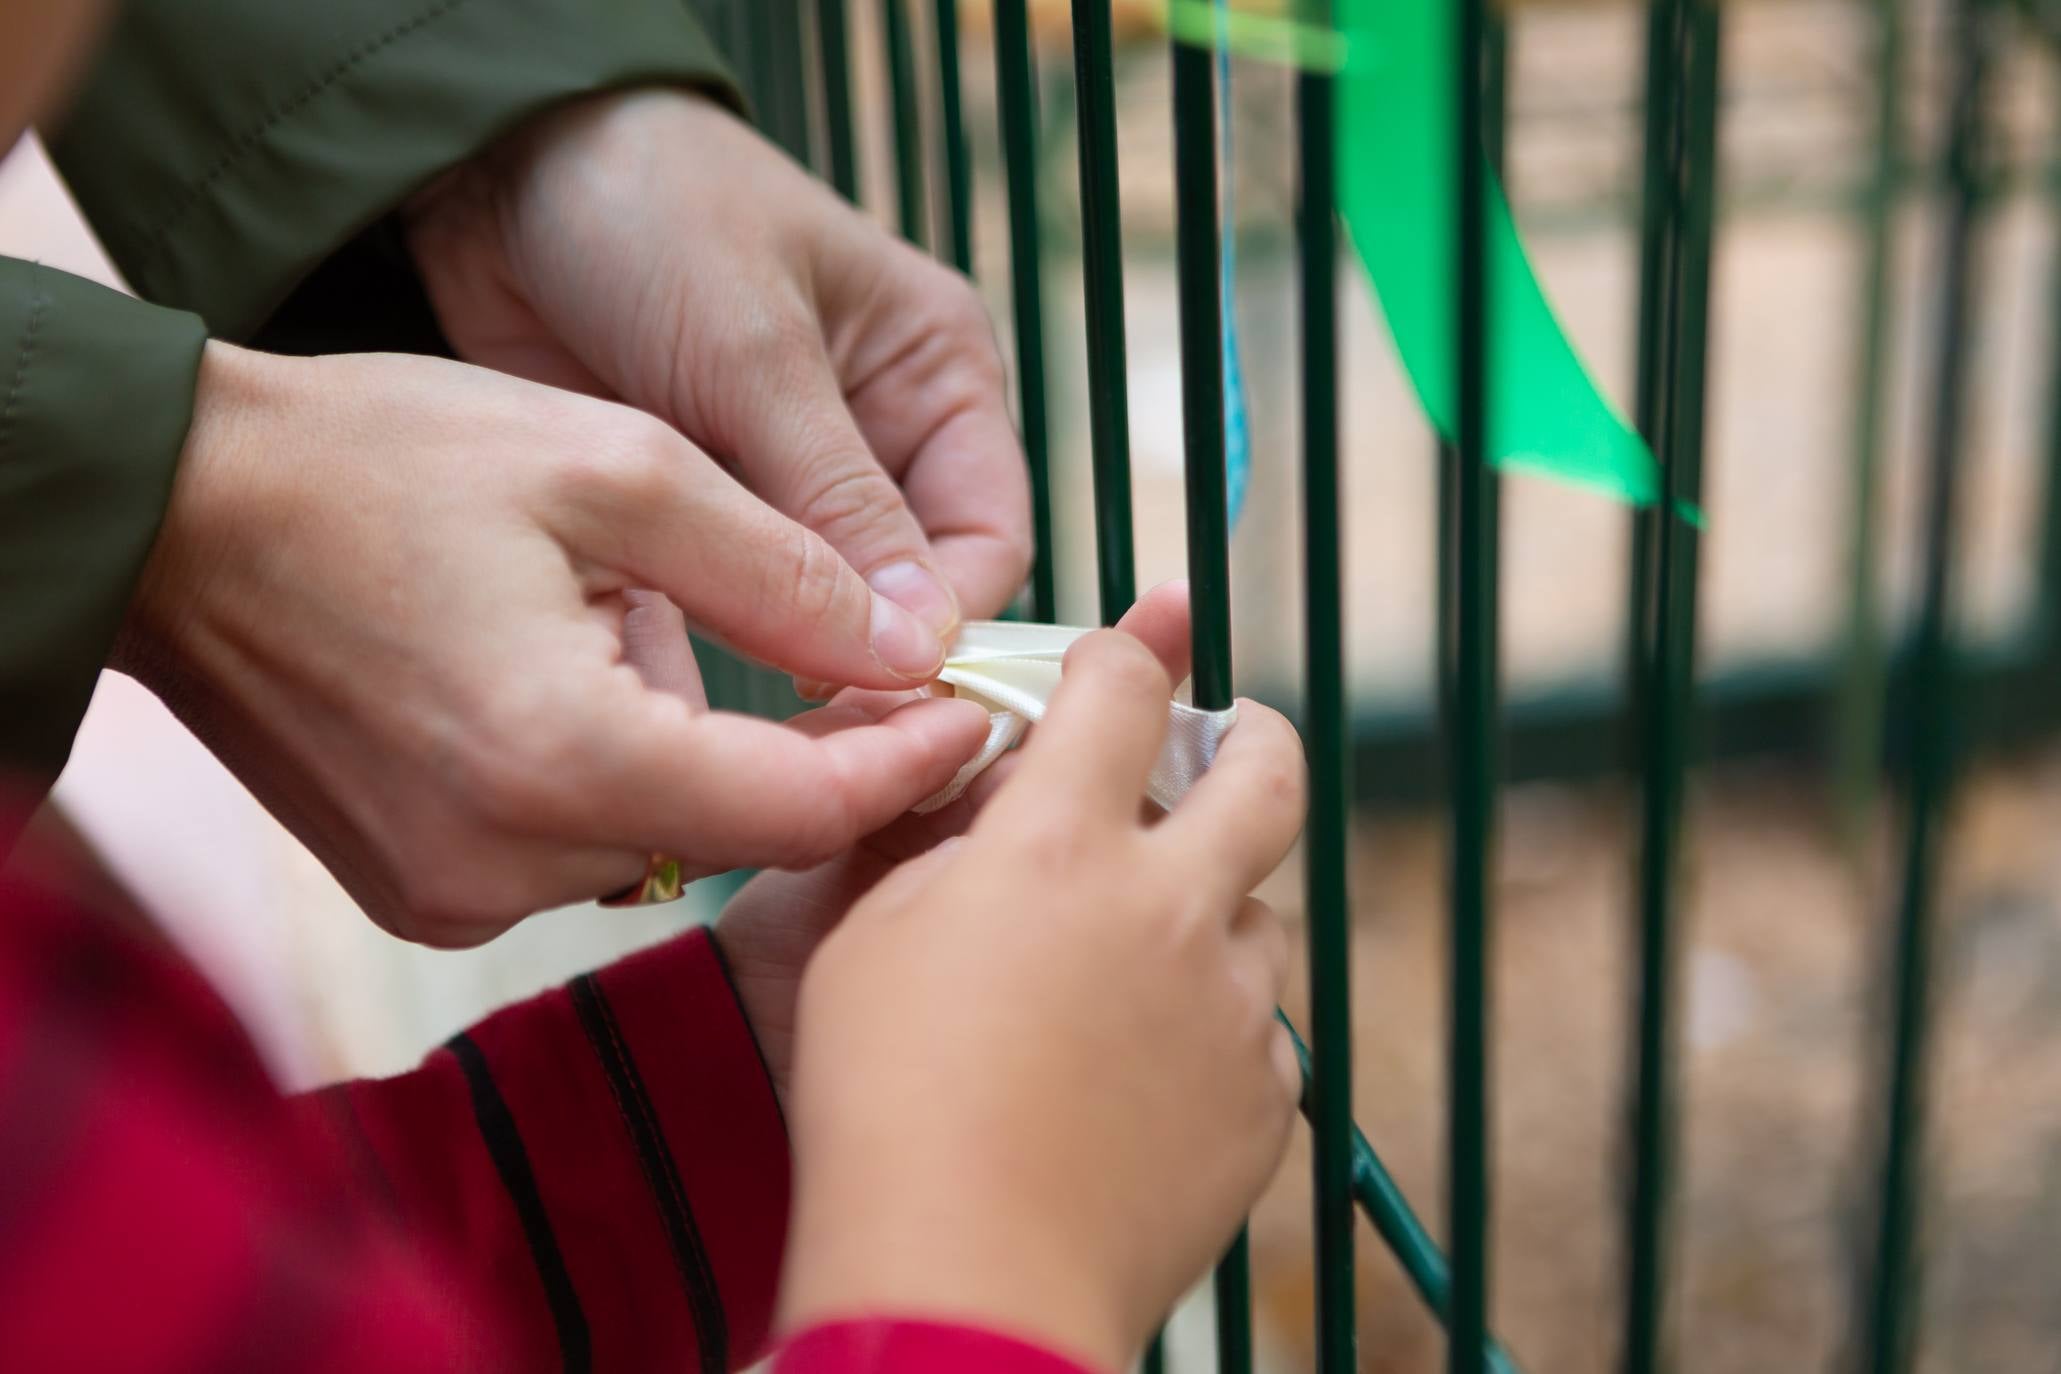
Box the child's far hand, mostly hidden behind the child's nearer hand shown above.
[715,581,1189,1094]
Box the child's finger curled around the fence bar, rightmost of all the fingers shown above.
[1152,698,1305,896]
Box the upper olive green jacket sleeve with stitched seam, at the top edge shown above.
[45,0,736,340]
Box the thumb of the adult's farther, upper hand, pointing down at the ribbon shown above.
[723,348,958,641]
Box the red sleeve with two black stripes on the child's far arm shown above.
[307,931,787,1374]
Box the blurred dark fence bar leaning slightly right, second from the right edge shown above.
[1865,0,1989,1374]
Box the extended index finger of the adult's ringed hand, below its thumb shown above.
[583,694,987,869]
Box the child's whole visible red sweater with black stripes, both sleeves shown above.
[0,855,1112,1374]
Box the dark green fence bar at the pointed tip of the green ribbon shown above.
[1624,0,1719,1374]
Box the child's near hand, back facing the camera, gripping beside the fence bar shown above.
[779,630,1305,1370]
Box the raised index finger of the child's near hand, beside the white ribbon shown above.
[991,630,1173,824]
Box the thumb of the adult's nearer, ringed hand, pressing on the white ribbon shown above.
[554,420,944,690]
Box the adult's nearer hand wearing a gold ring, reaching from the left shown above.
[113,344,985,946]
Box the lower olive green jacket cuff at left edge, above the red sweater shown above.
[0,257,206,807]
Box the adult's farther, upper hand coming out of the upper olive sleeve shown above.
[406,91,1031,671]
